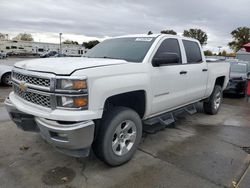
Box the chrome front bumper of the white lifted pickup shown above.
[5,98,95,157]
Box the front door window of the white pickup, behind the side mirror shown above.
[154,39,182,63]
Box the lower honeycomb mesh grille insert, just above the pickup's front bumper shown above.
[13,85,51,108]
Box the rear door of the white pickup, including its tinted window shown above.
[182,40,208,102]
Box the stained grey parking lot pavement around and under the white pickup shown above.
[0,58,250,188]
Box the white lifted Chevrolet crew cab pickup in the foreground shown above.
[5,35,229,166]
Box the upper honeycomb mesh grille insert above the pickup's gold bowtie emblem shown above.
[12,71,50,87]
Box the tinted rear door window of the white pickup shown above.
[183,40,202,63]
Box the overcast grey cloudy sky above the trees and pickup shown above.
[0,0,250,51]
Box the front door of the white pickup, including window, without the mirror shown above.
[151,38,188,114]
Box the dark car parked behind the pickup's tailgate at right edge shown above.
[224,62,248,96]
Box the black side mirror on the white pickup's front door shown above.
[152,52,179,67]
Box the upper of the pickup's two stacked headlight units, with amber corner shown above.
[56,79,87,90]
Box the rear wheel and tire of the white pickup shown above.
[203,85,223,115]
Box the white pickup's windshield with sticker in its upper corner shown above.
[85,37,155,62]
